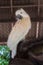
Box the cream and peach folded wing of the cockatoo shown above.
[7,19,28,48]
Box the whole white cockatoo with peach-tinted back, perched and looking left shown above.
[7,8,31,58]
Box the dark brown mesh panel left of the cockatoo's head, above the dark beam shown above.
[0,8,11,19]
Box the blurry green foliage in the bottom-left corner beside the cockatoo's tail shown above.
[0,45,10,65]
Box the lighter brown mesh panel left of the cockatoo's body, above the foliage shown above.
[0,23,11,41]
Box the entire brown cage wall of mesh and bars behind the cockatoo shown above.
[0,0,43,64]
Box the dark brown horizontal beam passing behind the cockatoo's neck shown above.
[0,17,43,22]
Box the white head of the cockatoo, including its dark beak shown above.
[15,8,29,20]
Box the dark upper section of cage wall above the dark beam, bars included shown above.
[0,0,43,20]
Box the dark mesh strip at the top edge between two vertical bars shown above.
[13,0,38,5]
